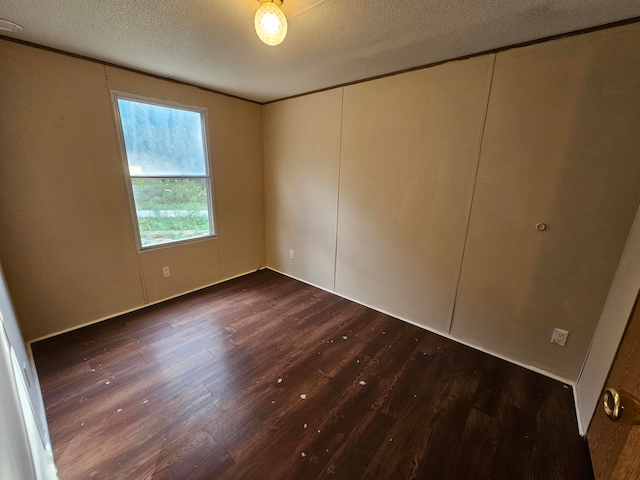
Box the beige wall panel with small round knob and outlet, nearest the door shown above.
[451,24,640,380]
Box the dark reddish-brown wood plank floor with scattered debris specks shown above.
[33,270,593,480]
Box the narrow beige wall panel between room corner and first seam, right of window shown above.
[264,89,342,290]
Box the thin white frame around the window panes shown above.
[111,90,218,251]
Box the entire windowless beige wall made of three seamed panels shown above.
[265,24,640,381]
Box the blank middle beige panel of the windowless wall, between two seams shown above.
[336,56,493,332]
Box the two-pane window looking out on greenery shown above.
[115,94,215,248]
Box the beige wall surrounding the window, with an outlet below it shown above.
[0,41,265,339]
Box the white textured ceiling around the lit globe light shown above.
[0,0,640,102]
